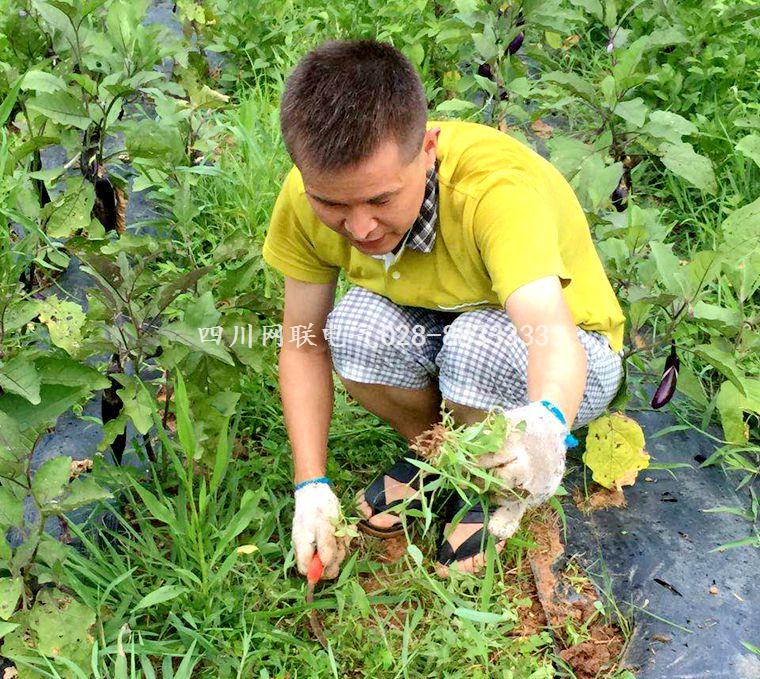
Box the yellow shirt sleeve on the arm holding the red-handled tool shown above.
[261,171,340,283]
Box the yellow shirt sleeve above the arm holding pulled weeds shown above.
[473,183,572,306]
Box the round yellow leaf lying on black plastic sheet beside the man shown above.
[583,413,649,490]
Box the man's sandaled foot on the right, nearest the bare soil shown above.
[435,495,507,577]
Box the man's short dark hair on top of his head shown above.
[280,40,427,171]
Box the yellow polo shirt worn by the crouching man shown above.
[262,120,625,352]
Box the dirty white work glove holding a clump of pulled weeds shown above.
[478,401,569,539]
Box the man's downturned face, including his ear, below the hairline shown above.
[301,127,441,255]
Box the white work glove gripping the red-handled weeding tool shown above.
[293,483,346,580]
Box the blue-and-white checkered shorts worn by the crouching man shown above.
[325,286,623,428]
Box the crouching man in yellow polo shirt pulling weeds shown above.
[263,41,624,578]
